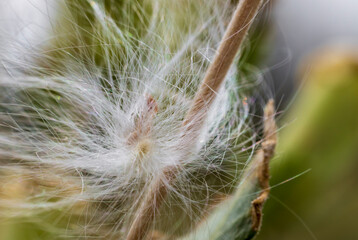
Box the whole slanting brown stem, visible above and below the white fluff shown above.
[127,0,263,240]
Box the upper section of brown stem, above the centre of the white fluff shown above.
[184,0,263,129]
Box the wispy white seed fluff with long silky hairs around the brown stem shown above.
[0,0,262,239]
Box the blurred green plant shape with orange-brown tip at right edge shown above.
[257,47,358,240]
